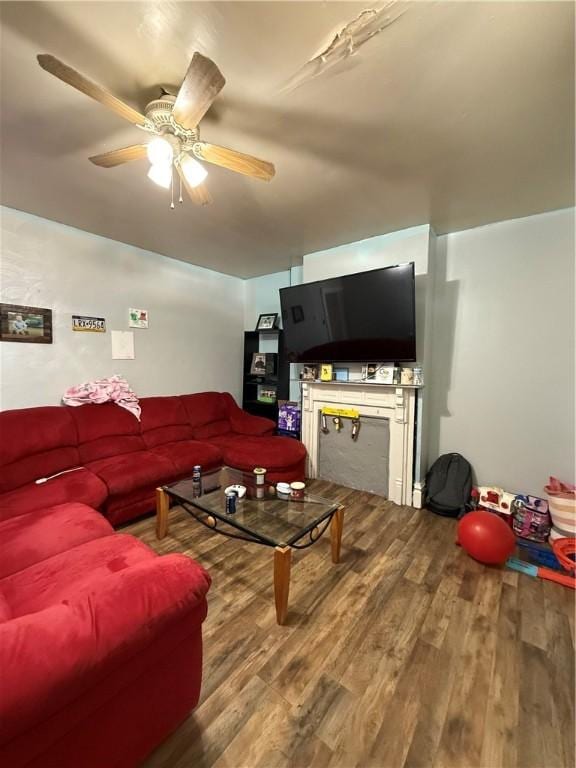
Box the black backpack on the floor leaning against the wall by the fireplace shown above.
[425,453,472,517]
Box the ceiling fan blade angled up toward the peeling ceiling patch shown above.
[172,52,226,129]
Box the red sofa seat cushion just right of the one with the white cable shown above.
[88,451,178,496]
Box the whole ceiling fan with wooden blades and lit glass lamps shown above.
[37,52,275,208]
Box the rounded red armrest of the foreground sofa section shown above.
[0,555,210,744]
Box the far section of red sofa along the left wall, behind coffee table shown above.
[0,392,306,525]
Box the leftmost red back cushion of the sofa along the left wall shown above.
[0,405,81,493]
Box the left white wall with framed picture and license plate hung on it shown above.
[0,207,244,409]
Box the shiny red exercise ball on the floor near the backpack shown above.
[458,510,516,565]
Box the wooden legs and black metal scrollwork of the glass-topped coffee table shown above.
[156,487,344,624]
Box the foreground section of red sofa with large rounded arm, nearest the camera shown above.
[0,503,210,768]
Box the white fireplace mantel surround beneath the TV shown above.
[302,381,422,507]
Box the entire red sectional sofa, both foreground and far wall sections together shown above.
[0,392,306,768]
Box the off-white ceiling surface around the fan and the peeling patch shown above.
[0,0,574,277]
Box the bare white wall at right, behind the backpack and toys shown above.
[428,210,575,495]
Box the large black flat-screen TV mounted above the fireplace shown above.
[280,264,416,363]
